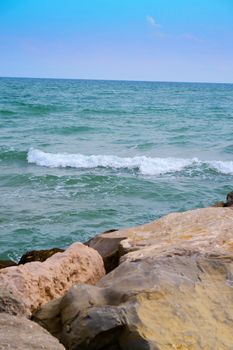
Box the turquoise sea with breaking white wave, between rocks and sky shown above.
[0,78,233,260]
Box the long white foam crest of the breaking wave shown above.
[27,148,233,175]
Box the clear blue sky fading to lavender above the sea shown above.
[0,0,233,83]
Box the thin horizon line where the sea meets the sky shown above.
[0,76,233,85]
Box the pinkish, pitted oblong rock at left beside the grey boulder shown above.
[0,243,105,315]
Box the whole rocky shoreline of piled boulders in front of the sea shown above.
[0,193,233,350]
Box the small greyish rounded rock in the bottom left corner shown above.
[0,313,65,350]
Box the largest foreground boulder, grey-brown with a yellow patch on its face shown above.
[35,254,233,350]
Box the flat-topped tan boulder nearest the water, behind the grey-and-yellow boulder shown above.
[88,207,233,261]
